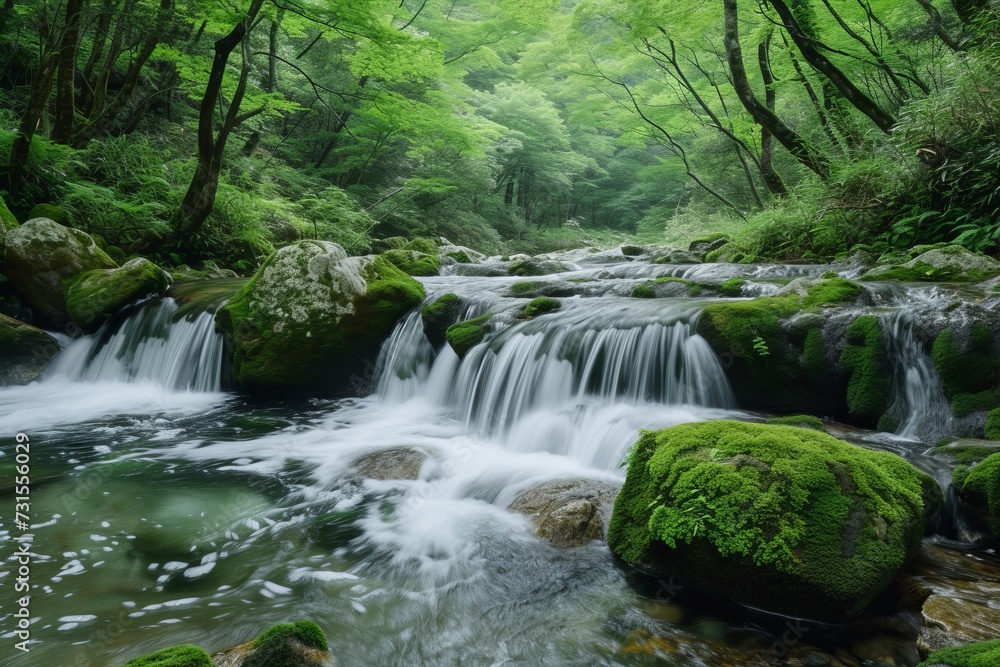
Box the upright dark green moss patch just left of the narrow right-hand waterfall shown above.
[840,315,892,426]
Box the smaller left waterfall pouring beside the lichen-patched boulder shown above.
[45,298,225,392]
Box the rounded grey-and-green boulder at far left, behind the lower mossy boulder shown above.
[4,218,118,326]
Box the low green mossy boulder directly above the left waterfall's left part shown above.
[64,257,170,332]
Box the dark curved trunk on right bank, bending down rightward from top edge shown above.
[723,0,830,179]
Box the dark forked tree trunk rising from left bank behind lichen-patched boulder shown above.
[175,0,264,240]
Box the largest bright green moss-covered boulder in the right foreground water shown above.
[608,420,942,622]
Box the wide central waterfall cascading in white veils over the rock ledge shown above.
[378,299,735,432]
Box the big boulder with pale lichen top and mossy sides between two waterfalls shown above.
[216,241,424,393]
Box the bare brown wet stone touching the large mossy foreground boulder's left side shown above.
[510,480,621,547]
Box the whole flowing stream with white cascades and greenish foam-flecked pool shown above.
[0,255,1000,667]
